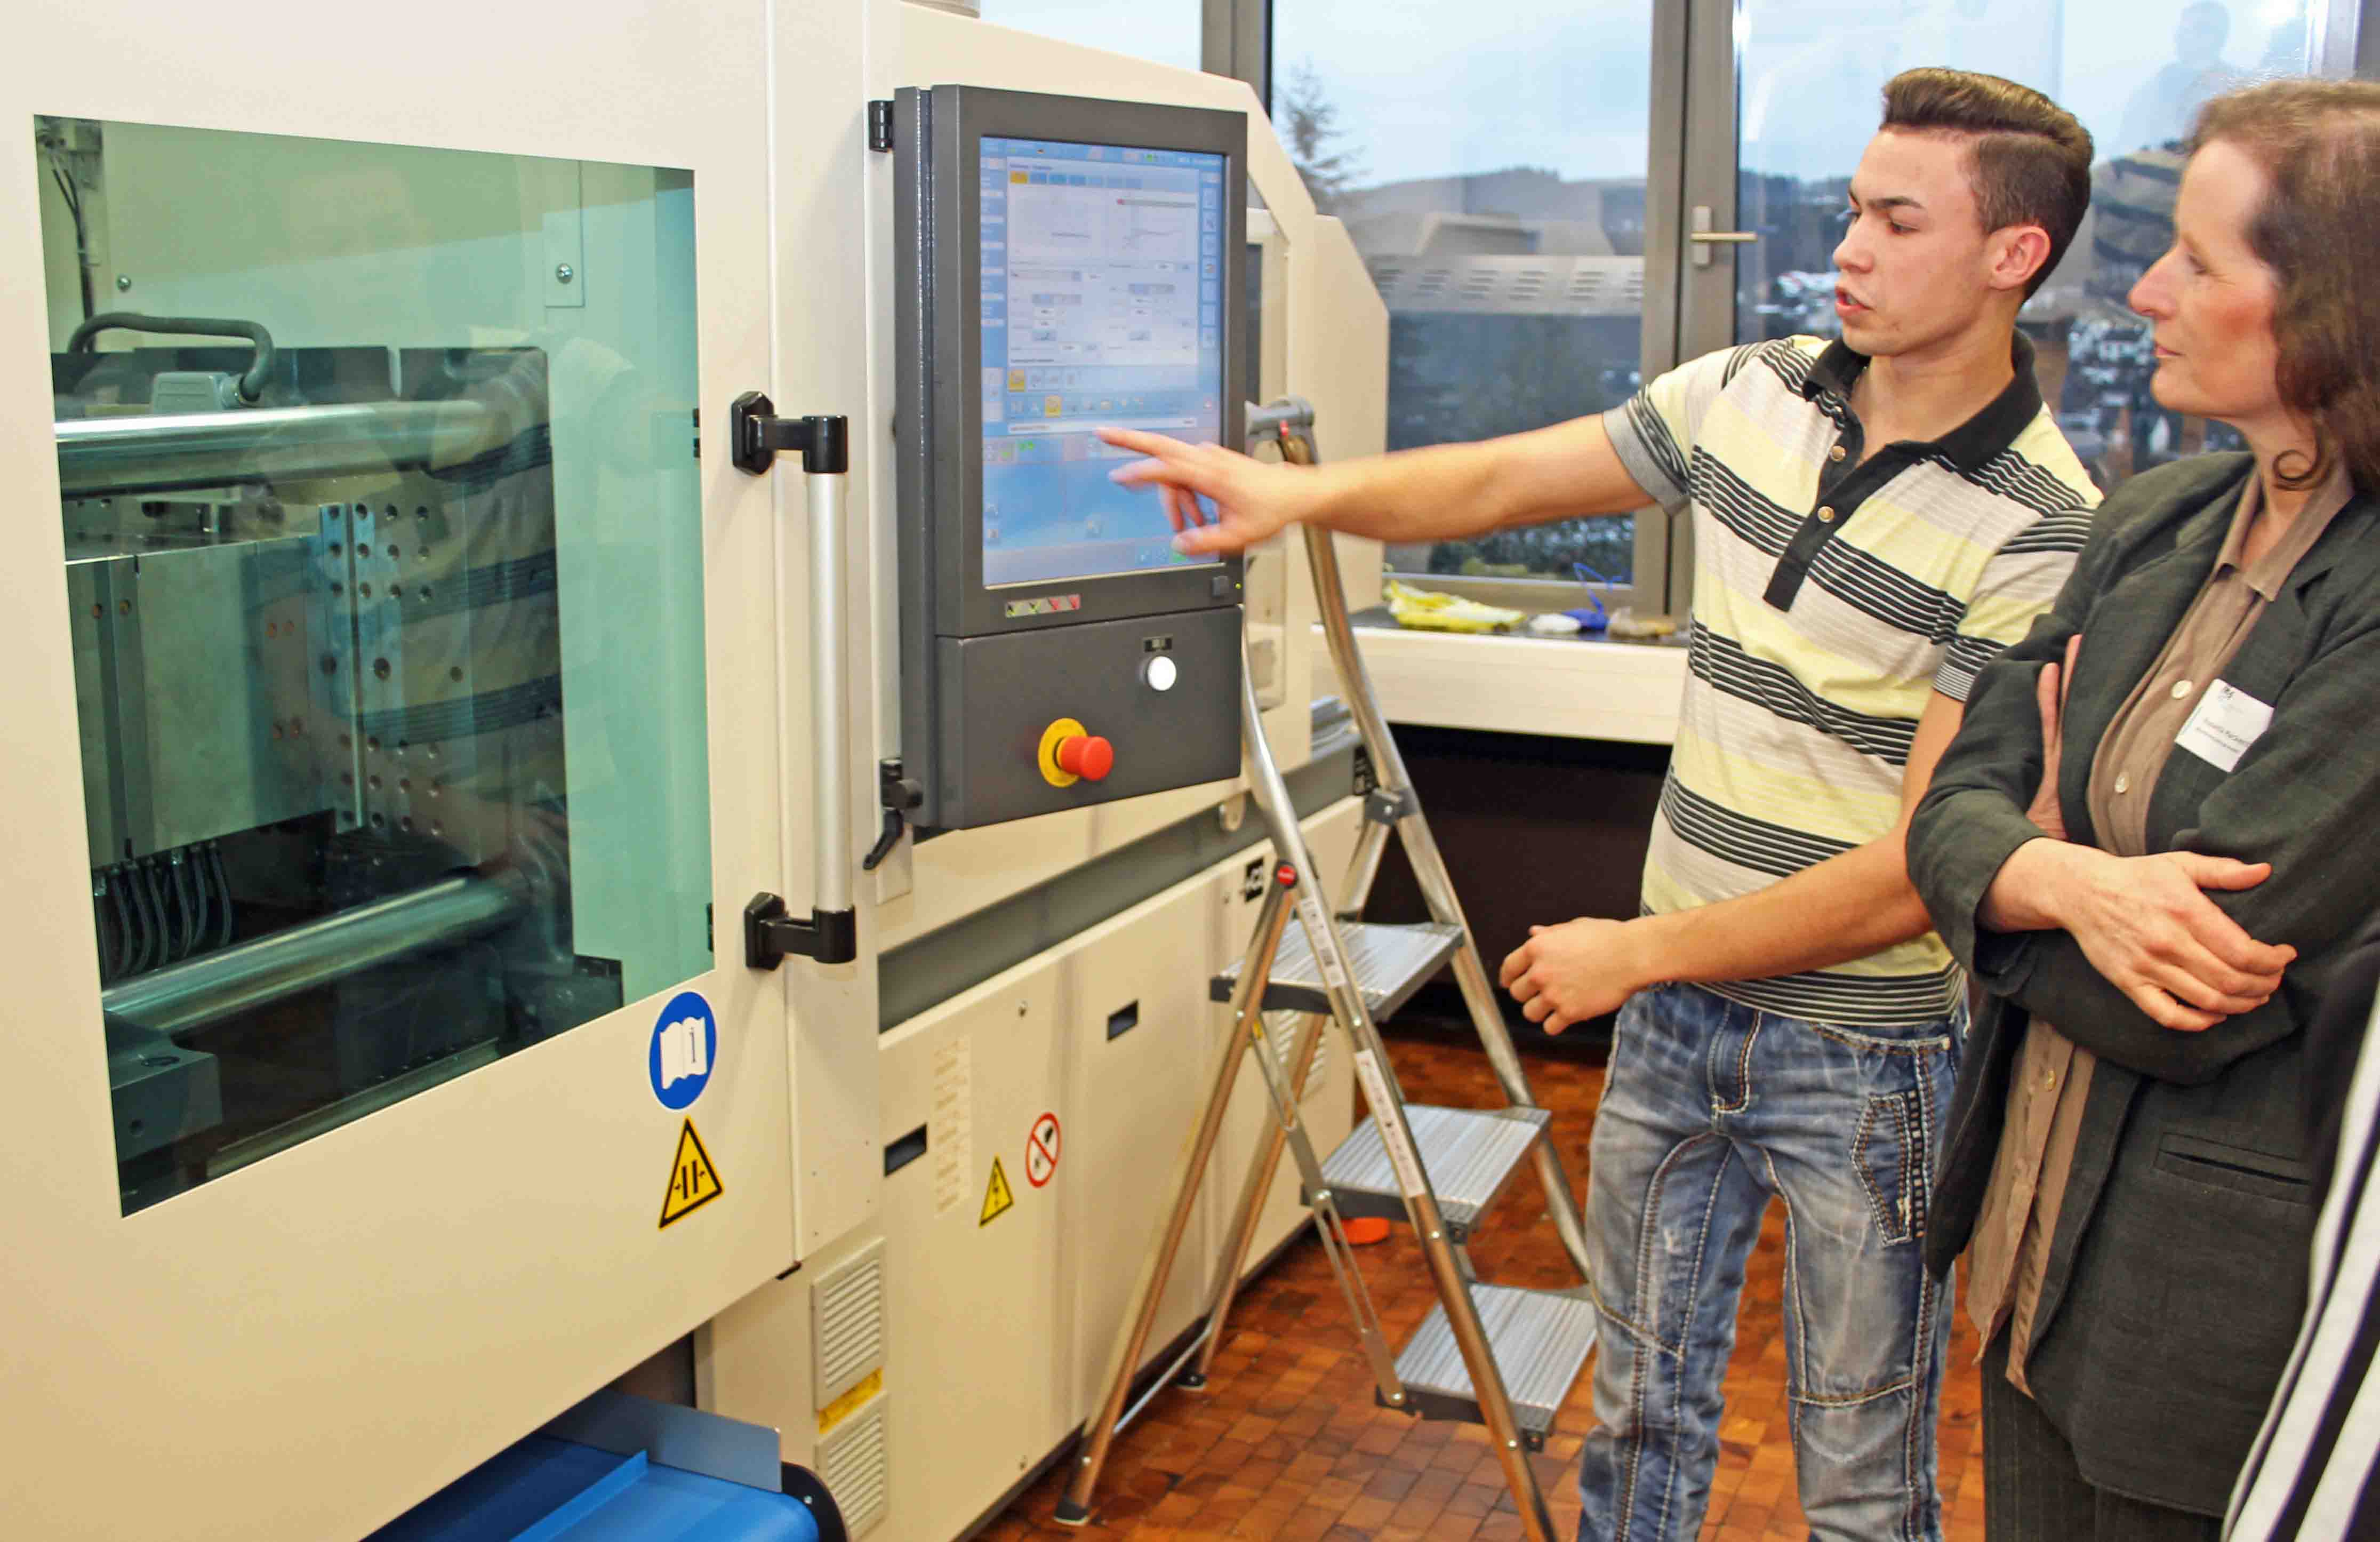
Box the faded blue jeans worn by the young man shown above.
[1578,985,1966,1542]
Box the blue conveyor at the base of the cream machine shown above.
[369,1394,843,1542]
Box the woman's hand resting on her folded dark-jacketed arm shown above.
[1985,840,2297,1033]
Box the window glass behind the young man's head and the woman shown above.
[1735,0,2311,488]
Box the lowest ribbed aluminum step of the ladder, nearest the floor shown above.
[1397,1285,1597,1451]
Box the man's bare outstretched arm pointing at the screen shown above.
[1100,417,1654,552]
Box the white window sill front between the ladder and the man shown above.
[1314,612,1685,745]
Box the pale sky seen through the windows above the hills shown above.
[983,0,2302,186]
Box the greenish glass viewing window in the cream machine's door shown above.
[36,119,711,1211]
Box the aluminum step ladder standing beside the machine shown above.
[1057,400,1597,1542]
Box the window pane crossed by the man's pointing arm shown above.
[1273,0,1652,583]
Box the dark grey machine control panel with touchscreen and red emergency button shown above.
[893,86,1247,830]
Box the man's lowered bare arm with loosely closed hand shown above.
[1504,690,1966,1033]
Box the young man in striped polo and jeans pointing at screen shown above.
[1109,69,2097,1542]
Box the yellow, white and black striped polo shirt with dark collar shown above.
[1604,335,2099,1028]
